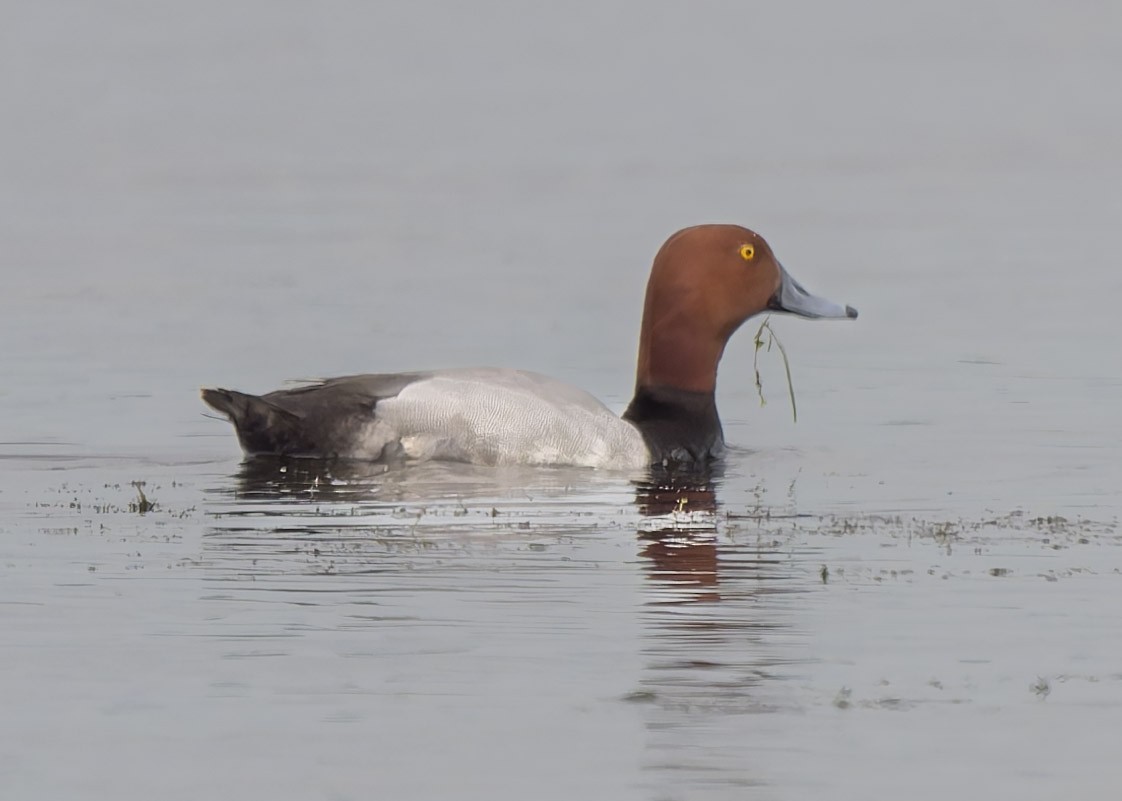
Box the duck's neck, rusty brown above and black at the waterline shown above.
[623,321,725,463]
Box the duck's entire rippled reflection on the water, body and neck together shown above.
[208,459,808,790]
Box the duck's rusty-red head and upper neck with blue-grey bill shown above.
[637,224,857,393]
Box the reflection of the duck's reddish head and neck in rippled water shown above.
[634,462,802,790]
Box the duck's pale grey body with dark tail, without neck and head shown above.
[203,367,650,470]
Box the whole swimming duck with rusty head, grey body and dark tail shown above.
[202,224,857,470]
